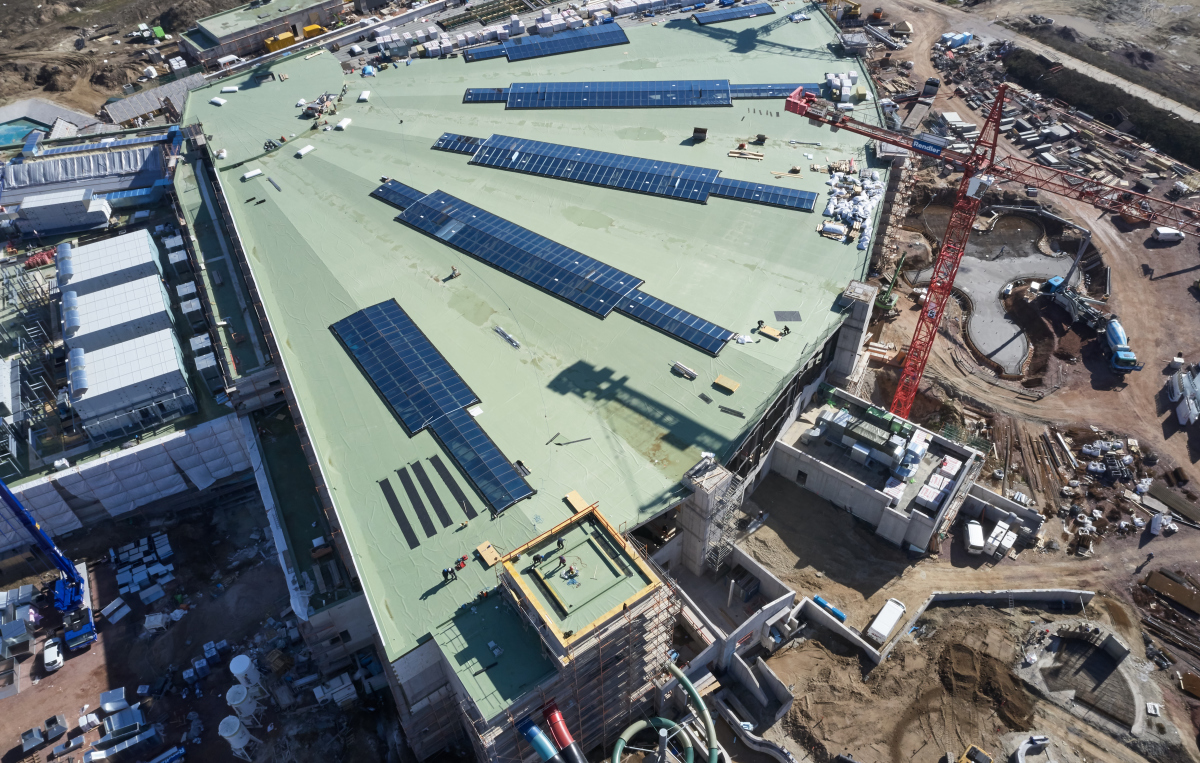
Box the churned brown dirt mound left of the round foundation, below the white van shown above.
[768,606,1187,763]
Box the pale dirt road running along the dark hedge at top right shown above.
[883,0,1200,122]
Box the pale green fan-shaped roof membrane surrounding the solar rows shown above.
[185,17,871,659]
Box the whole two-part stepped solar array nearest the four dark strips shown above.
[331,300,534,513]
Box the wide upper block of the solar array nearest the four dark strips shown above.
[332,300,479,435]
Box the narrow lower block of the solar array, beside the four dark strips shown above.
[430,410,535,511]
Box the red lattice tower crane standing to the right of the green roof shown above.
[785,84,1200,417]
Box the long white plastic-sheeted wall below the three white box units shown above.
[0,414,253,554]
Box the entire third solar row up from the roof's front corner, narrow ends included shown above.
[453,133,817,211]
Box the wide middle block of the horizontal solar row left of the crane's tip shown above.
[499,79,724,109]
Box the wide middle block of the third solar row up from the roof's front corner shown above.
[470,136,718,204]
